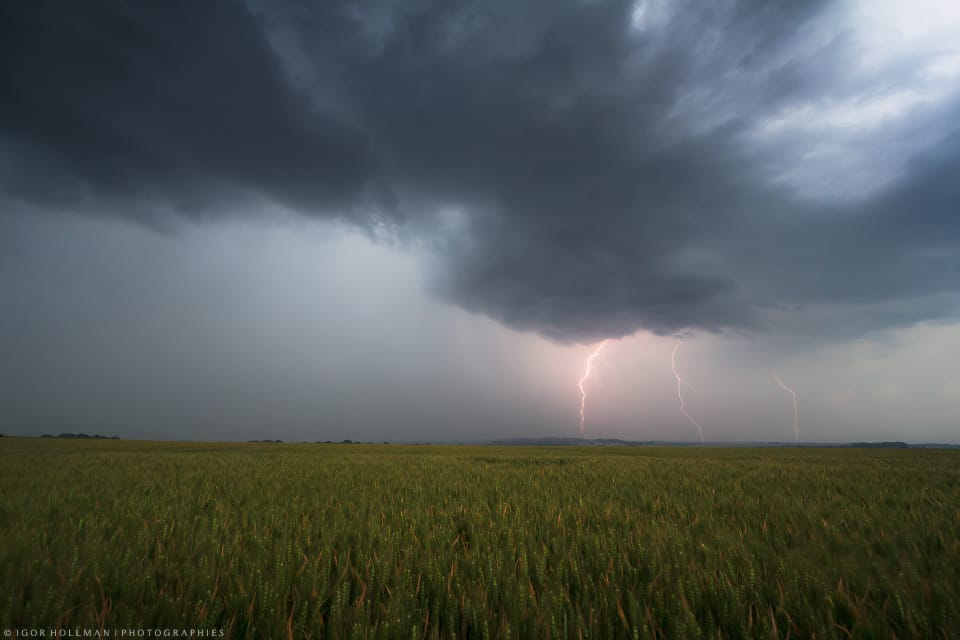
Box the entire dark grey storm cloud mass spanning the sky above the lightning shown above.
[0,0,958,341]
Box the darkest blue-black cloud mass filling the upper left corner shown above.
[0,0,386,216]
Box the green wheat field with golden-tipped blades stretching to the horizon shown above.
[0,438,960,638]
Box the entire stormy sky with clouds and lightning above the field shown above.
[0,0,960,443]
